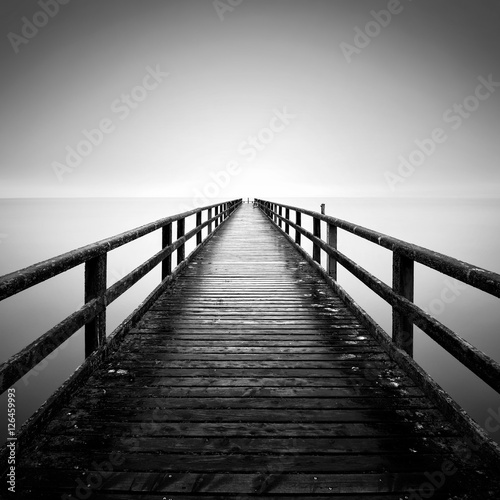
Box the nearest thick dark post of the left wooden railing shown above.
[85,253,107,358]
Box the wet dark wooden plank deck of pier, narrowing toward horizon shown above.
[8,205,499,500]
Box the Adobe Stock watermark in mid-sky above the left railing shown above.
[52,64,169,182]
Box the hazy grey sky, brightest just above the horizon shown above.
[0,0,500,198]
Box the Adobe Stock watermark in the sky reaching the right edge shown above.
[384,74,500,191]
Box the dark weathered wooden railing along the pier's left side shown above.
[0,199,242,394]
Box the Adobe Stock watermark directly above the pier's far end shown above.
[184,106,296,210]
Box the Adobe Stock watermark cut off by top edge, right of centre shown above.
[340,0,412,63]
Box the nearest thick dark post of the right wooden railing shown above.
[392,252,414,356]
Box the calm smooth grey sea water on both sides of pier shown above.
[0,198,500,442]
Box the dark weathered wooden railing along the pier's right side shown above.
[255,199,500,393]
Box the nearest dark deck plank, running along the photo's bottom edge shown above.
[13,470,494,500]
